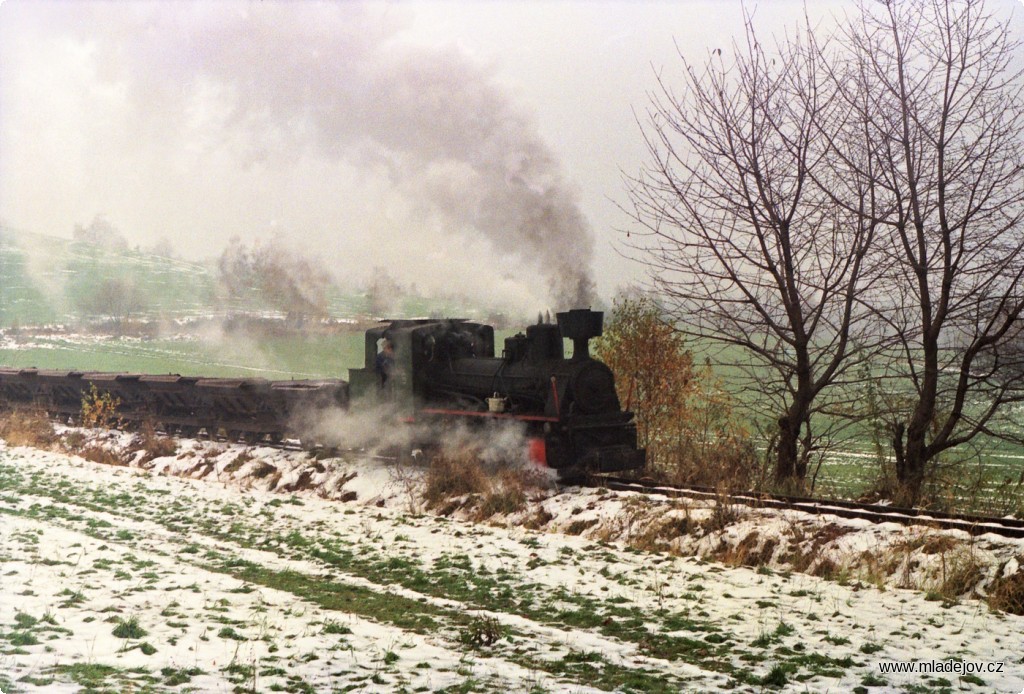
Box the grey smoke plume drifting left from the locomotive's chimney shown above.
[39,2,594,306]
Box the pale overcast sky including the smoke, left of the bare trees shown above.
[0,0,1010,308]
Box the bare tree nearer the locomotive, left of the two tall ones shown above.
[629,13,876,484]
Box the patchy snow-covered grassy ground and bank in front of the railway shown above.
[0,431,1024,694]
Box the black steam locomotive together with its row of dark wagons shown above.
[0,309,645,477]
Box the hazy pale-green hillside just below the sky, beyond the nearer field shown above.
[0,227,481,329]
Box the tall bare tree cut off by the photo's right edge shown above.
[835,0,1024,502]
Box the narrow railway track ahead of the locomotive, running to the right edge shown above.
[591,475,1024,537]
